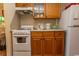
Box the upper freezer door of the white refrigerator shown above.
[69,5,79,26]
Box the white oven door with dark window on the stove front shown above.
[13,35,31,52]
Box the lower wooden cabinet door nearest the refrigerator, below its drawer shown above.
[55,38,64,56]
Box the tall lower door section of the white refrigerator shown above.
[66,27,79,56]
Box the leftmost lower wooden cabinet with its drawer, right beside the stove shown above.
[31,32,42,56]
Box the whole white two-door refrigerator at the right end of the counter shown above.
[60,5,79,56]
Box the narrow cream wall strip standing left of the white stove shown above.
[4,3,15,56]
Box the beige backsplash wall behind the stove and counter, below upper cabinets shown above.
[20,15,59,25]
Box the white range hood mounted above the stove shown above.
[16,7,33,15]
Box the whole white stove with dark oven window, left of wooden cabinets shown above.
[12,27,31,56]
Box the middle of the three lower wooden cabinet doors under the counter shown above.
[43,38,54,56]
